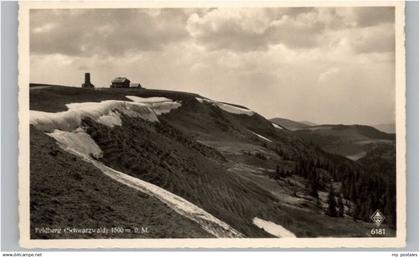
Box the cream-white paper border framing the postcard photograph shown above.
[18,1,406,249]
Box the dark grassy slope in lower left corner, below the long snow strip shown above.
[30,128,211,239]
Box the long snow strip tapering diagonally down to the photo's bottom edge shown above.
[47,128,243,237]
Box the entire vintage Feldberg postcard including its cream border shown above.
[19,1,406,248]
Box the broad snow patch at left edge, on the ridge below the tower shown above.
[30,100,158,132]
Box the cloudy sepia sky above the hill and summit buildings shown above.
[30,7,395,124]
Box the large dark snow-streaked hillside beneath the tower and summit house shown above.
[30,85,395,238]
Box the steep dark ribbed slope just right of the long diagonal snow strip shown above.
[84,118,275,237]
